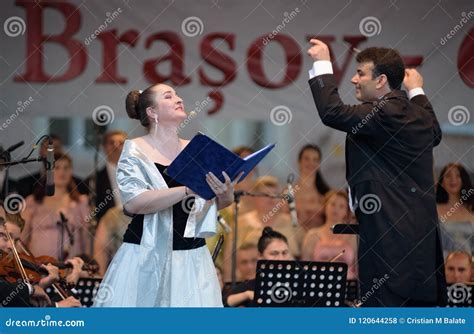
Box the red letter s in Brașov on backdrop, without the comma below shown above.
[199,33,237,87]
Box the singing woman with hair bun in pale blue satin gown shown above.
[94,84,241,307]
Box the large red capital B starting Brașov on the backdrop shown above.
[14,0,87,82]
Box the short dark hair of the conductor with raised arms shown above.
[356,47,405,89]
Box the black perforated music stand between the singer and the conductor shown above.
[254,260,348,307]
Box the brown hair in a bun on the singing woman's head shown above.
[125,85,156,127]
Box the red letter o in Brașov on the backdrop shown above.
[247,34,302,89]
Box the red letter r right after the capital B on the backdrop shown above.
[95,29,140,83]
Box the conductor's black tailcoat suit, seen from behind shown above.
[309,74,446,305]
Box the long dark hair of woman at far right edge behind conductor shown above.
[436,163,474,212]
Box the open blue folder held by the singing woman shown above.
[165,133,275,199]
